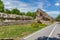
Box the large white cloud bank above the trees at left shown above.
[2,0,36,12]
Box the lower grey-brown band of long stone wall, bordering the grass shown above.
[0,20,34,26]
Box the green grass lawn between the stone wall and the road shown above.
[0,24,45,38]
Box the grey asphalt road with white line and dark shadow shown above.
[23,23,60,40]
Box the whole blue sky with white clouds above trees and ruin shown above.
[2,0,60,18]
